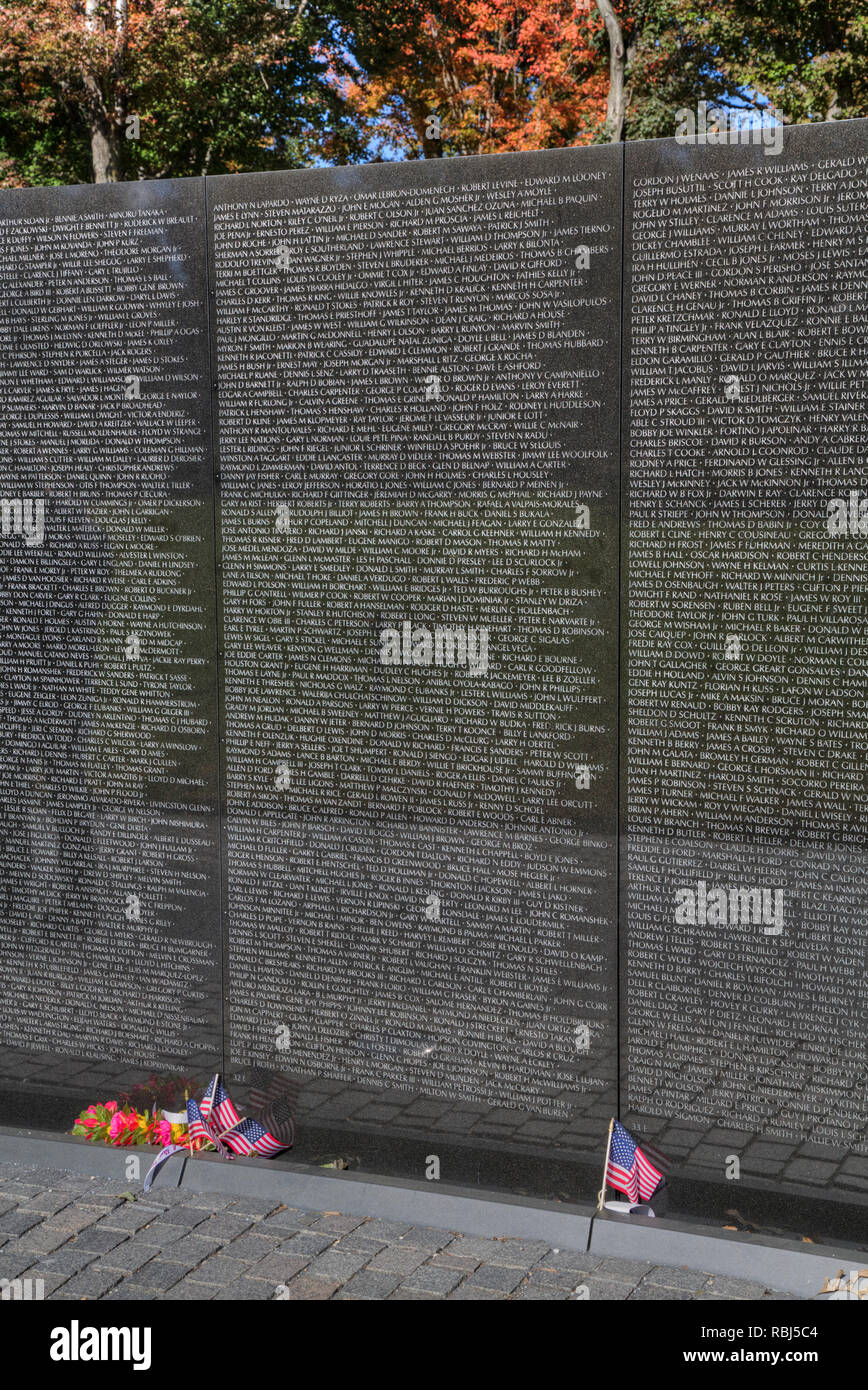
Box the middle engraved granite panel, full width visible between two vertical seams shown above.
[209,149,620,1195]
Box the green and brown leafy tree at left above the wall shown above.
[0,0,355,182]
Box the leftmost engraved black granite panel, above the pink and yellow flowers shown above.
[0,179,221,1123]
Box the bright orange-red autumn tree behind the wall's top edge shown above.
[319,0,617,158]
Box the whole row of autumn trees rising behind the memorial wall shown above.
[0,0,868,186]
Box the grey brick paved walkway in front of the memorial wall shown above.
[0,1163,793,1301]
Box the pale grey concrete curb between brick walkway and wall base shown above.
[0,1127,868,1298]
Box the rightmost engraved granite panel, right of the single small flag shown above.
[620,121,868,1205]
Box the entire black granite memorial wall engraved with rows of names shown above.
[0,121,868,1230]
